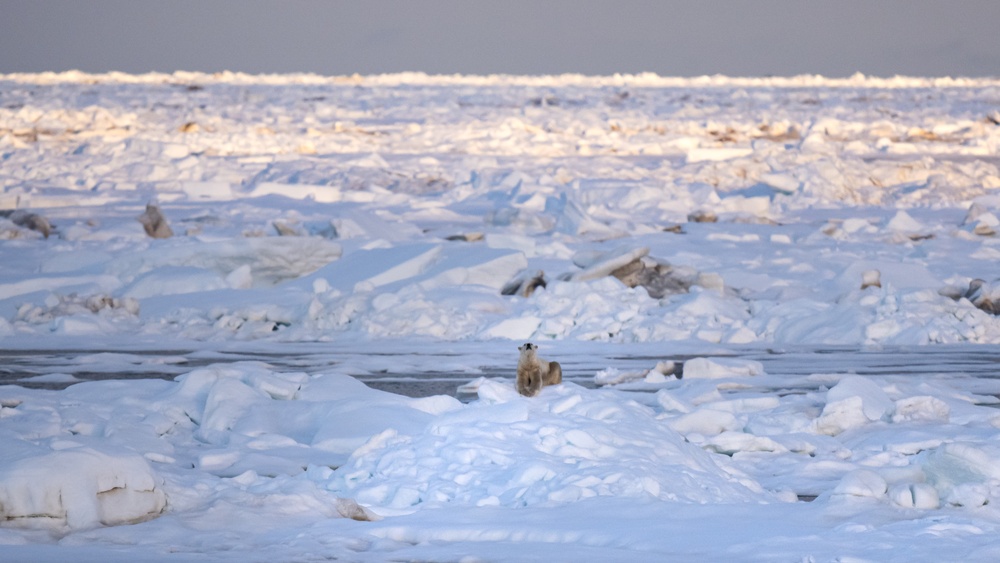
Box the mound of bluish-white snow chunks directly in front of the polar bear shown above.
[329,380,773,513]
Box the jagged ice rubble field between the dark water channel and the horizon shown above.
[0,73,1000,344]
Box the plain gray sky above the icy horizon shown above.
[0,0,1000,76]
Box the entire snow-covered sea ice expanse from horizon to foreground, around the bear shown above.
[0,72,1000,561]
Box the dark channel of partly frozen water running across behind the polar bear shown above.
[0,345,1000,398]
